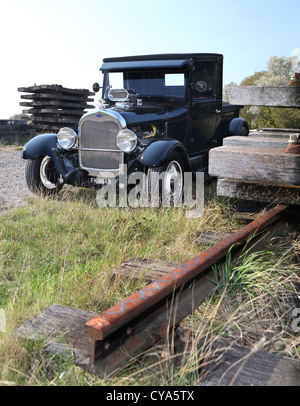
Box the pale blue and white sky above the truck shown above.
[0,0,300,118]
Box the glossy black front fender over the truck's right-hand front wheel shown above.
[137,139,192,171]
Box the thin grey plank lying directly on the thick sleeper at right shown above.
[223,136,288,151]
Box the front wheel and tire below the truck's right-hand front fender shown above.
[146,153,184,207]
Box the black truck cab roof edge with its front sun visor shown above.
[100,54,223,72]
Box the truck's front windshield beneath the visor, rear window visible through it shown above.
[103,71,187,100]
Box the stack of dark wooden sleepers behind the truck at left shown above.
[18,85,95,131]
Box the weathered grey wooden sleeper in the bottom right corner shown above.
[203,342,300,386]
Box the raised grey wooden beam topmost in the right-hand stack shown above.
[228,86,300,107]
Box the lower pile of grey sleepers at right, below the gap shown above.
[209,129,300,205]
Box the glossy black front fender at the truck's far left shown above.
[22,134,75,181]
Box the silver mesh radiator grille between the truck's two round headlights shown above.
[78,115,123,176]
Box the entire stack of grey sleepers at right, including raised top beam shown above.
[209,85,300,206]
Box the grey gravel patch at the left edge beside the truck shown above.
[0,147,32,212]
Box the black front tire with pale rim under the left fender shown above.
[25,156,63,196]
